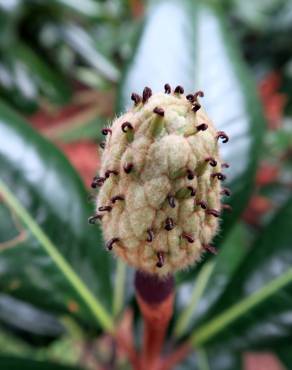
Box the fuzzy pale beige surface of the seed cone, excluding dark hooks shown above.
[97,93,221,275]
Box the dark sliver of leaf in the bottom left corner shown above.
[0,355,81,370]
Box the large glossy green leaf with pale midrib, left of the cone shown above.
[0,103,113,330]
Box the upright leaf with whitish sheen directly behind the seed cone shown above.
[118,0,263,246]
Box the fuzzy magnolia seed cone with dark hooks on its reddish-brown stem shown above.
[89,84,230,369]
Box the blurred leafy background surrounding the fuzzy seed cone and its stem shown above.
[0,0,292,370]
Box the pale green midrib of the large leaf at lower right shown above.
[190,268,292,346]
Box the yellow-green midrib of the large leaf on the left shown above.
[0,180,114,333]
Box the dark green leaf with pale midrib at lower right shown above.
[192,198,292,348]
